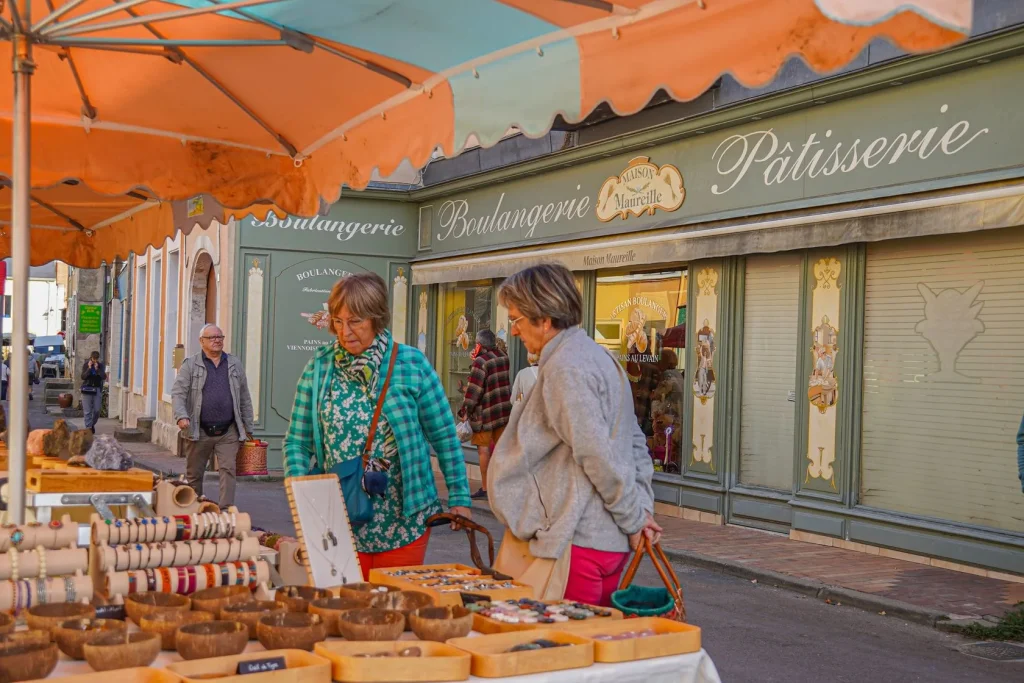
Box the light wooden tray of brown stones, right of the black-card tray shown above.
[313,640,470,683]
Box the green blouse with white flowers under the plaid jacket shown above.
[319,334,441,553]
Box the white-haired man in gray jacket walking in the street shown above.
[171,325,253,509]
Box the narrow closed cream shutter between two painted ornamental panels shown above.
[739,254,805,490]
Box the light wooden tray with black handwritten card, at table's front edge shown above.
[165,650,331,683]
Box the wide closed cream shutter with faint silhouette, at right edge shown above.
[860,228,1024,531]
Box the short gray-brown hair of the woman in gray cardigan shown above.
[498,263,583,330]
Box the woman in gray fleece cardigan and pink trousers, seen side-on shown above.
[487,265,662,605]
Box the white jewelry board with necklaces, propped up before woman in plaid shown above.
[285,474,362,588]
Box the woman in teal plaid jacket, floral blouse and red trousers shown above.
[285,273,470,580]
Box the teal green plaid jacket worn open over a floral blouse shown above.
[285,340,471,516]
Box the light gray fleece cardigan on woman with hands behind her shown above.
[487,328,654,559]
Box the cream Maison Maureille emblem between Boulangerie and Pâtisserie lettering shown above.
[596,157,686,222]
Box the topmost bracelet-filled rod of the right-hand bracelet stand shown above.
[92,507,252,546]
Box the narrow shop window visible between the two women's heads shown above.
[437,281,496,413]
